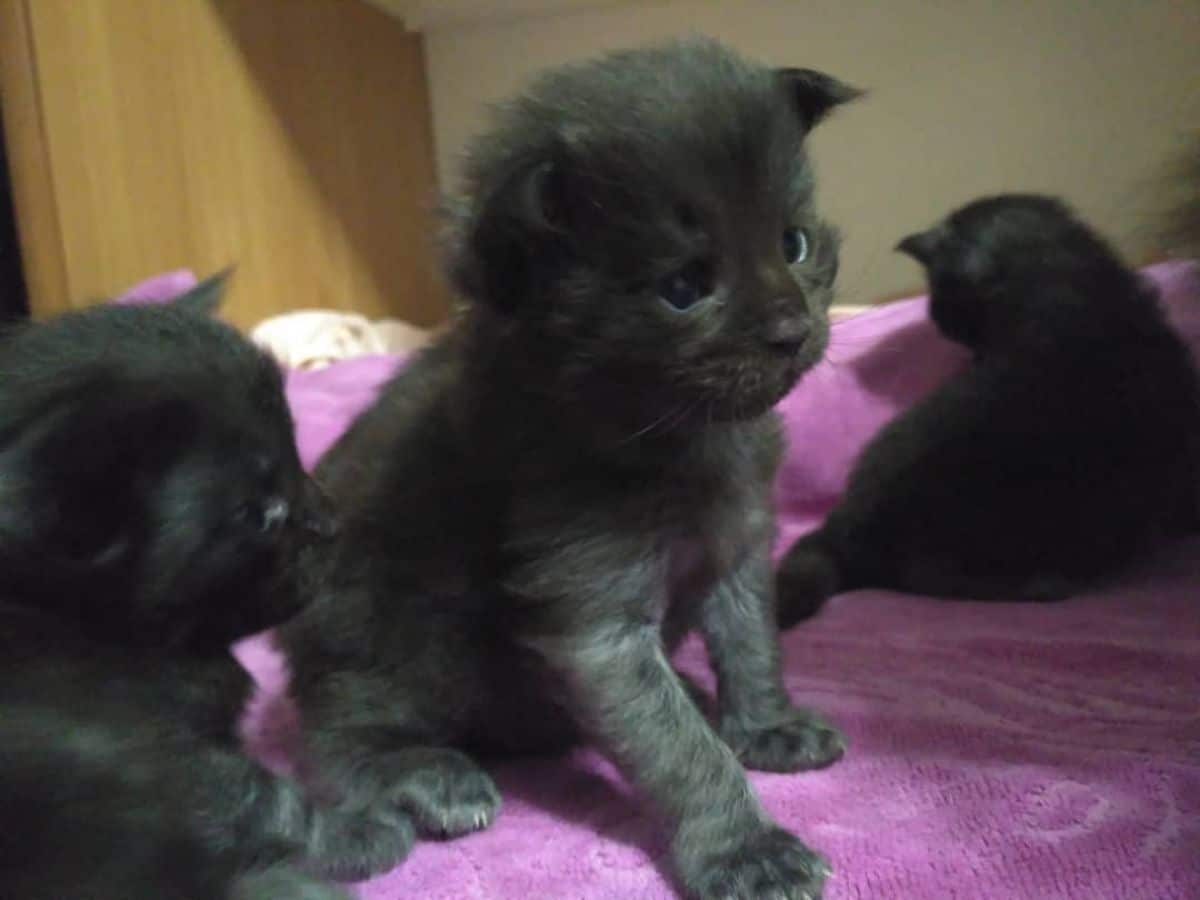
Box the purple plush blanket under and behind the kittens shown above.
[220,265,1200,900]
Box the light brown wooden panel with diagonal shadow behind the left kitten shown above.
[7,0,446,325]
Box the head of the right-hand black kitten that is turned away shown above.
[896,194,1128,349]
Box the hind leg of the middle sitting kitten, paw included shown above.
[283,592,500,838]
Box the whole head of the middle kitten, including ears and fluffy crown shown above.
[452,42,856,421]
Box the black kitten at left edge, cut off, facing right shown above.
[0,281,410,900]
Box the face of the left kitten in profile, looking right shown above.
[127,359,329,653]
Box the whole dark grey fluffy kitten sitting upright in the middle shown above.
[283,41,856,898]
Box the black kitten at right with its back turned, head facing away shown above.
[779,196,1200,625]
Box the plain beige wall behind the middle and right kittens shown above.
[426,0,1200,304]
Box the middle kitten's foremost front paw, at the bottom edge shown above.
[684,826,829,900]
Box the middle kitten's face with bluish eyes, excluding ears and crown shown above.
[544,141,838,419]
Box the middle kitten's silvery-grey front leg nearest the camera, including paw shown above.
[537,619,828,900]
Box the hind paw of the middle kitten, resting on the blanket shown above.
[388,748,500,838]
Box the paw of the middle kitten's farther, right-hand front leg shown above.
[721,707,846,772]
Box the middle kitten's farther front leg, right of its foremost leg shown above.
[700,546,846,772]
